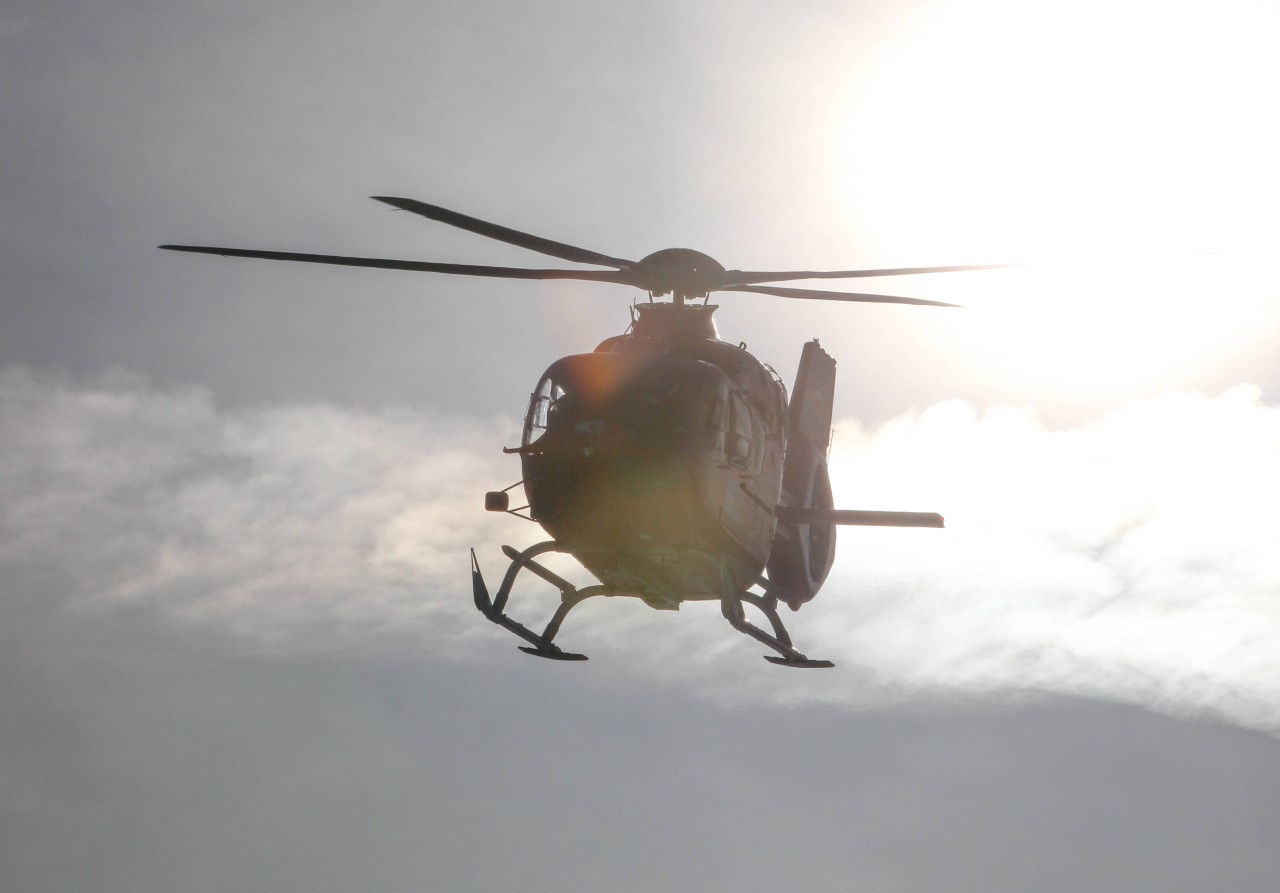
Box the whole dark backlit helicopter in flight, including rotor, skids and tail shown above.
[160,196,1010,667]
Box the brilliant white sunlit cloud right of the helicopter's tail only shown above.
[814,386,1280,732]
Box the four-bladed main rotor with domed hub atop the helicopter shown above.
[160,196,1019,307]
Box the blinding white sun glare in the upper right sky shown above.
[832,0,1280,394]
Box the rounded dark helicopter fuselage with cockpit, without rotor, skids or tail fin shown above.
[518,304,787,608]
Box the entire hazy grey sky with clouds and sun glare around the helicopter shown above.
[0,0,1280,893]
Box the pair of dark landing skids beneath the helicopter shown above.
[471,540,835,668]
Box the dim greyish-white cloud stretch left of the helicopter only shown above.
[0,370,513,649]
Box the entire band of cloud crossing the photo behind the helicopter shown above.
[0,368,1280,733]
